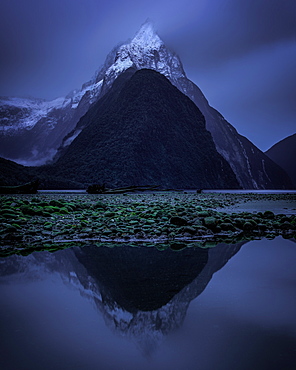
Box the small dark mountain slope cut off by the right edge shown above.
[265,134,296,189]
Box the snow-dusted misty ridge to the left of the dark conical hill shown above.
[0,82,102,166]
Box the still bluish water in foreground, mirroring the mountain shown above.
[0,237,296,370]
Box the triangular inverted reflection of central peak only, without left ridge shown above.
[74,243,243,355]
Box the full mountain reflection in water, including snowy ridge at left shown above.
[1,243,244,355]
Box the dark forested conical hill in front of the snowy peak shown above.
[50,69,238,188]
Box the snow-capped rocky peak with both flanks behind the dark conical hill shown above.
[0,22,291,189]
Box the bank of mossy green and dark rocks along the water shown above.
[0,192,296,257]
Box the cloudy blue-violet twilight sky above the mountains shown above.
[0,0,296,151]
